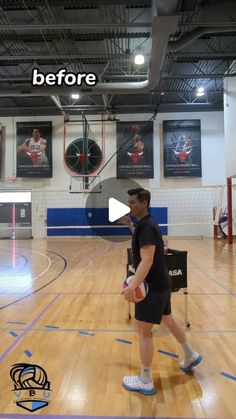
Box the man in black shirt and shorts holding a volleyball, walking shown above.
[121,188,202,395]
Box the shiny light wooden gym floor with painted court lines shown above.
[0,238,236,419]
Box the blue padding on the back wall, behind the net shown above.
[47,207,168,236]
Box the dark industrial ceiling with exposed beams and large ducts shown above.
[0,0,236,118]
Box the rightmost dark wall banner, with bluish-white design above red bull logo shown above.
[163,119,202,177]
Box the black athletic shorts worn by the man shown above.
[135,289,171,324]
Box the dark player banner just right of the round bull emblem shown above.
[117,121,153,179]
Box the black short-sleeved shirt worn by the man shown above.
[132,214,171,291]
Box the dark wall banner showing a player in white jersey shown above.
[16,121,52,178]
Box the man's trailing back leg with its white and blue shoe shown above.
[162,314,202,372]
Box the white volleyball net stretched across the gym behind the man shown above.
[0,182,227,238]
